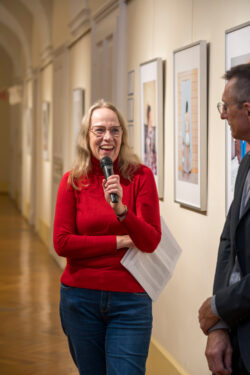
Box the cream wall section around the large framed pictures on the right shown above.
[127,0,250,375]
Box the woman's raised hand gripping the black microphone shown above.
[102,174,124,215]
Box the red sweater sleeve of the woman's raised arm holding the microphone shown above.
[121,166,161,253]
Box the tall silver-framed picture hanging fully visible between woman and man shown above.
[174,40,207,211]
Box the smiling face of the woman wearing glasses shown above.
[89,107,122,162]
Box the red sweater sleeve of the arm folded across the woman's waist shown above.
[53,173,116,259]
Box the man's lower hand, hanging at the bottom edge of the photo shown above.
[205,329,232,375]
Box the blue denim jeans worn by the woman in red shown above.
[60,284,152,375]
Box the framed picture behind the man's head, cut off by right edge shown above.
[225,22,250,214]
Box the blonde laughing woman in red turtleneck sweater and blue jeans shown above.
[54,100,161,375]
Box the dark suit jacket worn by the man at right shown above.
[214,152,250,371]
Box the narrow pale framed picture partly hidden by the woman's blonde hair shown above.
[73,88,85,158]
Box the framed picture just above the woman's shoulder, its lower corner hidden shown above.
[140,58,164,199]
